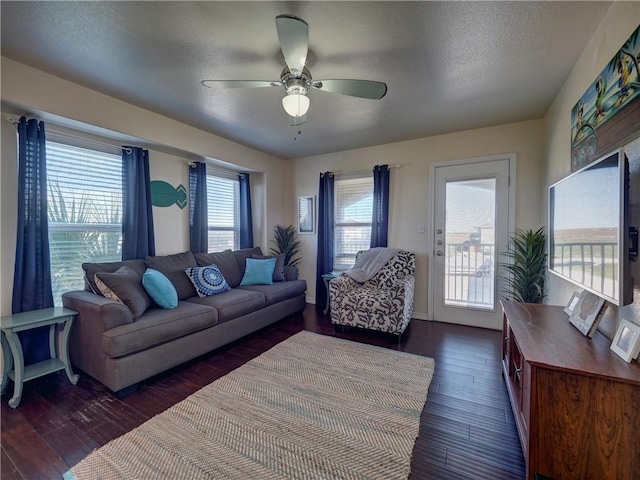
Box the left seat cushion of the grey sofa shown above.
[102,302,218,358]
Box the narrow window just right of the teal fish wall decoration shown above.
[207,171,240,252]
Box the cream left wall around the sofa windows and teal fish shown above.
[0,57,290,315]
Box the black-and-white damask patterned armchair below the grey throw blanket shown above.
[329,250,416,336]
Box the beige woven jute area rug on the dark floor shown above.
[65,332,434,480]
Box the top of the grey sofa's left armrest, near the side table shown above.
[62,290,133,335]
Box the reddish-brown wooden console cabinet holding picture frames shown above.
[502,301,640,480]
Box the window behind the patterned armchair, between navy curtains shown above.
[333,175,373,271]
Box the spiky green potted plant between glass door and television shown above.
[501,227,547,303]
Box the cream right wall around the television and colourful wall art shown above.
[540,2,640,335]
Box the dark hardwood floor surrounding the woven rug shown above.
[0,305,525,480]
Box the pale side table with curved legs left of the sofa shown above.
[0,307,78,408]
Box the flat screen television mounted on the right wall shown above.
[548,150,633,305]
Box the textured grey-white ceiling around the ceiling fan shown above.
[1,1,611,159]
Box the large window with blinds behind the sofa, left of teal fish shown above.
[47,141,122,306]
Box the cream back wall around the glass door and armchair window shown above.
[288,120,544,319]
